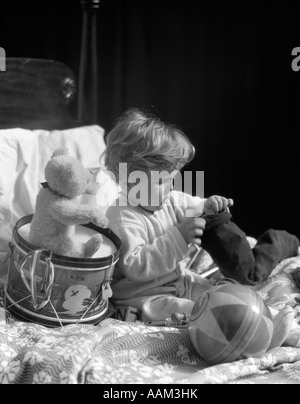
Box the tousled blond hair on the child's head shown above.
[105,109,195,180]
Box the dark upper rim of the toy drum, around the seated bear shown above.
[13,215,121,269]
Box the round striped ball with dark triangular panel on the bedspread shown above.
[189,283,274,365]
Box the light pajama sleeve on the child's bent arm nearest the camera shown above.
[108,210,188,282]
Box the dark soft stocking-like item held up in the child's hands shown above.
[191,212,299,285]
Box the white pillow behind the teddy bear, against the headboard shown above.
[0,125,105,252]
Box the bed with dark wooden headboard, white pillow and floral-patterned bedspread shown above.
[0,0,300,386]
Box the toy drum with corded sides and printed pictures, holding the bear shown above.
[6,215,121,327]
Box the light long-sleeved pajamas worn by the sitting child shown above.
[107,191,207,321]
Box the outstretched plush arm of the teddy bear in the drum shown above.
[49,200,105,225]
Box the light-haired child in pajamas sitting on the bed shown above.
[105,109,233,321]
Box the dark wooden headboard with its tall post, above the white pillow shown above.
[0,0,100,130]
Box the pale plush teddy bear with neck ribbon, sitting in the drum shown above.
[29,149,108,258]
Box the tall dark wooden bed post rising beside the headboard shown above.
[78,0,100,125]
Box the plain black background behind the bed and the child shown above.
[0,0,300,237]
